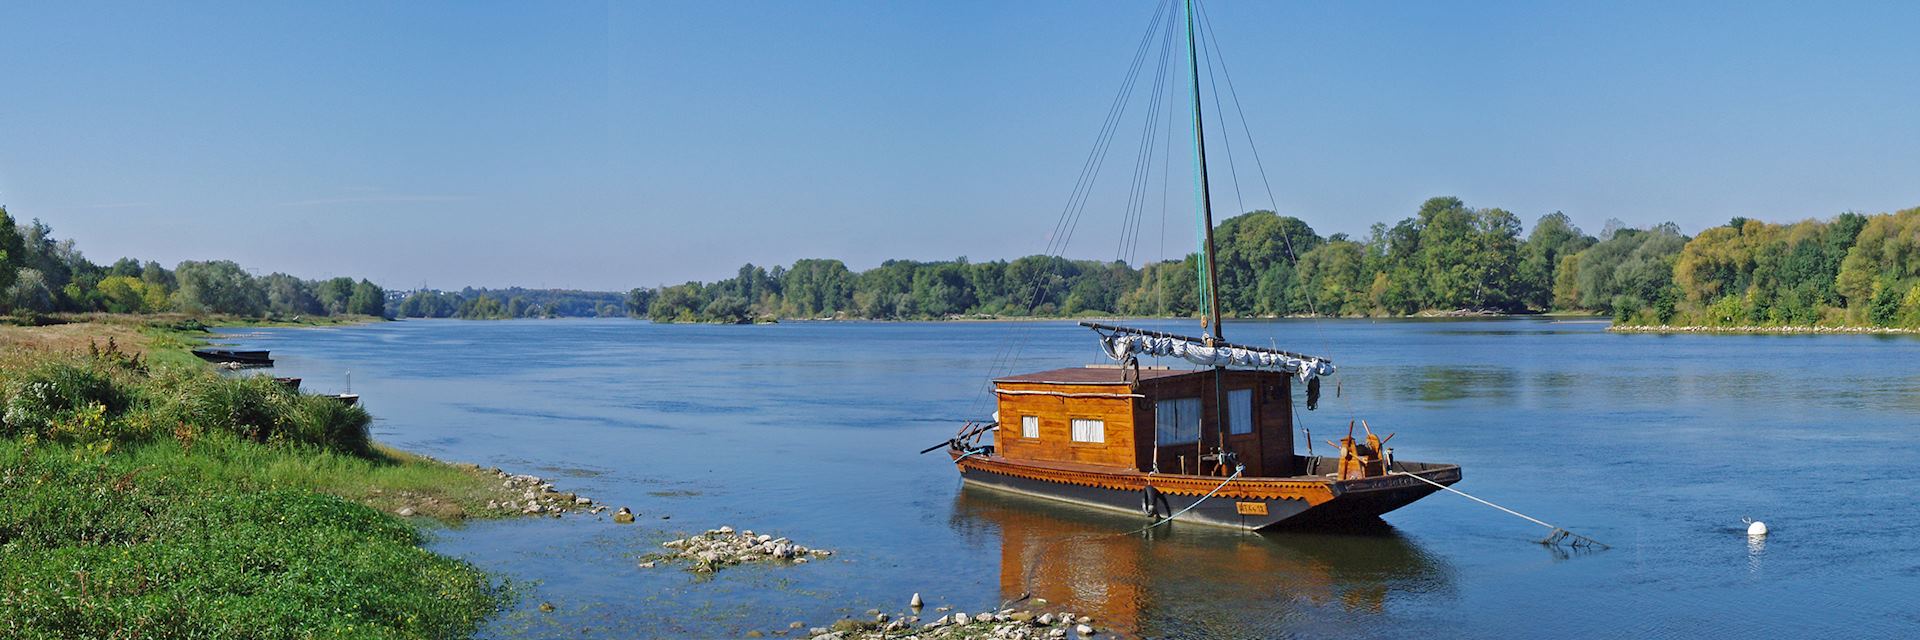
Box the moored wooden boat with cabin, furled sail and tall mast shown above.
[929,0,1461,529]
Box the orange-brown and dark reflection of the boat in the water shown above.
[952,486,1453,638]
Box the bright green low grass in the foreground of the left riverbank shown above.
[0,440,503,638]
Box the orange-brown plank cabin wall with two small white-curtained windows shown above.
[993,382,1152,469]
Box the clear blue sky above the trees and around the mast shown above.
[0,0,1920,288]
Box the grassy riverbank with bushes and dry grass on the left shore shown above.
[0,323,520,638]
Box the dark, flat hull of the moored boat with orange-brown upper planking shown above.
[958,457,1461,530]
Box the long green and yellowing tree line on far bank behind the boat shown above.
[626,198,1920,327]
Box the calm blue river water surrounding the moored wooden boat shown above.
[230,319,1920,638]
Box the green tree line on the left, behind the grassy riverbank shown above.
[0,206,386,317]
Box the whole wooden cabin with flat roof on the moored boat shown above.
[993,365,1304,477]
